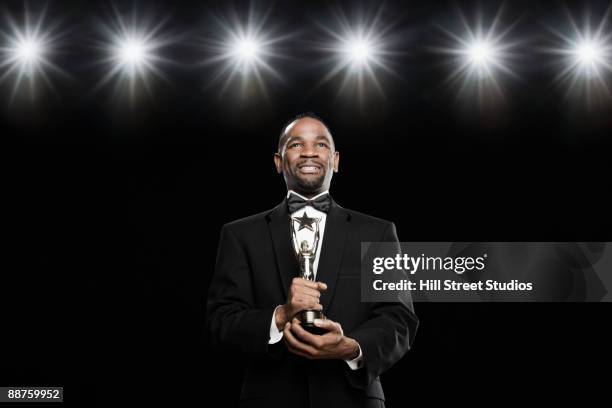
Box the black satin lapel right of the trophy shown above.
[317,201,350,313]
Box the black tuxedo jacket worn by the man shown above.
[207,196,418,408]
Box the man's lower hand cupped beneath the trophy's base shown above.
[283,319,359,360]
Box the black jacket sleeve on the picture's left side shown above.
[206,225,275,355]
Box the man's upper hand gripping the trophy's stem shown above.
[275,278,327,330]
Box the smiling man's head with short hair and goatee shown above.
[274,113,340,197]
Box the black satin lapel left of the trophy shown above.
[268,201,299,297]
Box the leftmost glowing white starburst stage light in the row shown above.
[0,4,66,103]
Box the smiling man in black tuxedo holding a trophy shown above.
[207,114,418,408]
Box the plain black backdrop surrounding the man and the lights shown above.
[0,1,612,407]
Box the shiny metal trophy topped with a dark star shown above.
[290,211,326,334]
